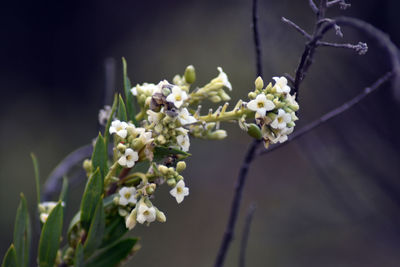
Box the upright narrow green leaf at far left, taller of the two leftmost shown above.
[14,194,32,267]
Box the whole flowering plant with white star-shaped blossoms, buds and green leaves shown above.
[5,59,299,266]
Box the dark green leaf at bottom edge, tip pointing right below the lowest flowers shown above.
[85,238,138,267]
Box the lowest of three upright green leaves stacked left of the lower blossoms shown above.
[83,199,106,258]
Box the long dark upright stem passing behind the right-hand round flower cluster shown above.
[214,0,262,267]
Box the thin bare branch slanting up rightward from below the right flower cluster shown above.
[257,71,393,156]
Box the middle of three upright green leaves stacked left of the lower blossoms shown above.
[81,168,103,231]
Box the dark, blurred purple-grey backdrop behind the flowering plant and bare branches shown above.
[0,0,400,267]
